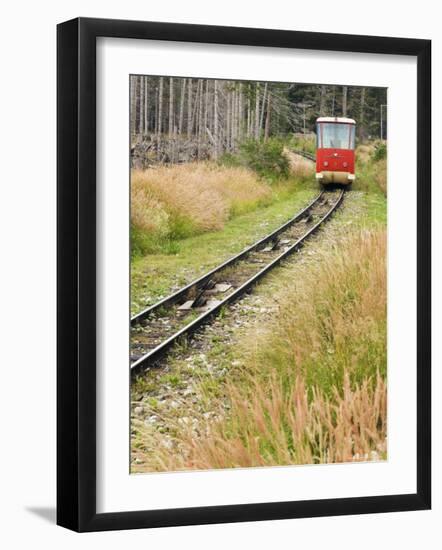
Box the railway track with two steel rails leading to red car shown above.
[130,190,345,374]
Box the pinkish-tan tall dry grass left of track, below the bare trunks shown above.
[131,163,271,252]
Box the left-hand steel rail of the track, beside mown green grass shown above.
[130,191,324,326]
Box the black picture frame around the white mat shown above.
[57,18,431,531]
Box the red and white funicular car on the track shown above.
[316,117,356,185]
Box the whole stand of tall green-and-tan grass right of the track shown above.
[133,230,387,471]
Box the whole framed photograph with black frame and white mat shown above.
[57,18,431,531]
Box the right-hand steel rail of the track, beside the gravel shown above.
[130,189,345,374]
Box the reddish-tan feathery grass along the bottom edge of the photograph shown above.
[138,376,387,471]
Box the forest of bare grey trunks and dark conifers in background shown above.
[130,76,387,168]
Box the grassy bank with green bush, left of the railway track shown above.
[131,143,317,313]
